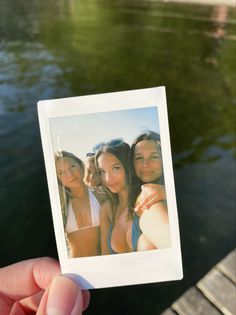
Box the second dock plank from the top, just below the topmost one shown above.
[197,268,236,315]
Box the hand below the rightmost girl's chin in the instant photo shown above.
[134,183,166,216]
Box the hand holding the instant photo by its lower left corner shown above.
[0,257,89,315]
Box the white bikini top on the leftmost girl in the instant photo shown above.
[65,188,101,234]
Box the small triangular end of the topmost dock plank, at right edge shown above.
[216,249,236,284]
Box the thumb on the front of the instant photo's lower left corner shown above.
[46,276,83,315]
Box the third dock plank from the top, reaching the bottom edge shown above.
[172,287,221,315]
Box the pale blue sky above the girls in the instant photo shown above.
[50,107,159,160]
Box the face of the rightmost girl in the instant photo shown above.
[133,140,162,183]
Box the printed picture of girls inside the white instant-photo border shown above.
[49,106,171,258]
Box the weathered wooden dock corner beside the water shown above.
[161,249,236,315]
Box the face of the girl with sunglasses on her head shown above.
[97,152,126,193]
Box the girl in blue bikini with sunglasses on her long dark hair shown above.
[95,139,141,255]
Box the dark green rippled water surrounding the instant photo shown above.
[0,0,236,315]
